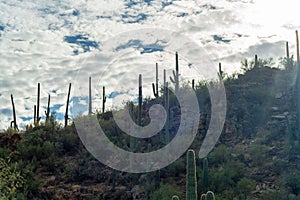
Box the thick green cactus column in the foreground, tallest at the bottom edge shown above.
[186,149,197,200]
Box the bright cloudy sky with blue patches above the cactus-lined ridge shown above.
[0,0,300,129]
